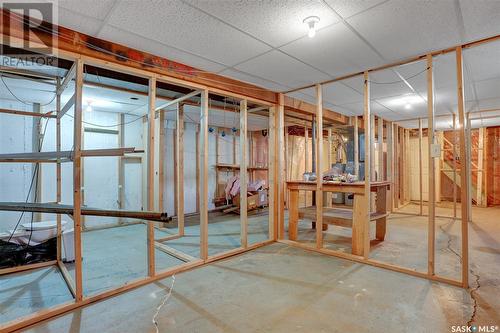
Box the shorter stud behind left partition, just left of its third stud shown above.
[176,103,184,236]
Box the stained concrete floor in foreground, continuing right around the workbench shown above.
[0,205,500,332]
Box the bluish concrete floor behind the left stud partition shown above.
[0,211,268,324]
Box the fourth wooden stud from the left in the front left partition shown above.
[240,99,248,248]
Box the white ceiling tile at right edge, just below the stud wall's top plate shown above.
[463,44,500,81]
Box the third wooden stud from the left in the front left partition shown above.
[199,90,209,260]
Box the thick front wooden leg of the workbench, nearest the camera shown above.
[352,194,370,258]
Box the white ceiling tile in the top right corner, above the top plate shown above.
[460,0,500,42]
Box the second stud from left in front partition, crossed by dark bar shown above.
[146,77,156,277]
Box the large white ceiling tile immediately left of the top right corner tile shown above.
[347,0,460,61]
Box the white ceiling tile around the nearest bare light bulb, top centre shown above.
[184,0,338,47]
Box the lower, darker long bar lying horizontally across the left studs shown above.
[0,202,172,222]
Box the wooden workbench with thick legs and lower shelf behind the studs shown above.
[287,181,390,255]
